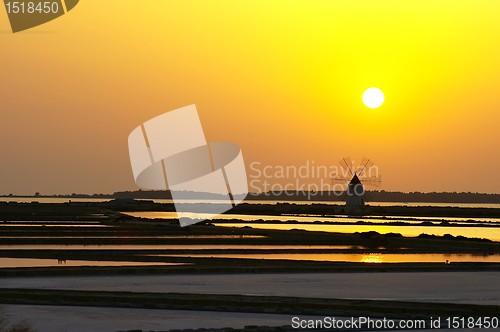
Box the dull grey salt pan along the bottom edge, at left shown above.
[0,305,300,332]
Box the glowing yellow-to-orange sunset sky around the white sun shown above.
[0,0,500,194]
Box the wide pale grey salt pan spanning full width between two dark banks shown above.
[0,272,500,305]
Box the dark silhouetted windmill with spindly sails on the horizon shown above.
[332,157,382,209]
